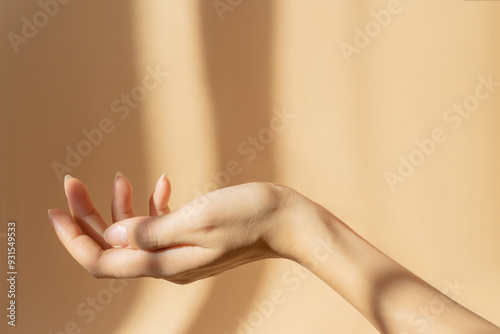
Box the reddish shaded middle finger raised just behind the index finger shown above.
[64,175,110,249]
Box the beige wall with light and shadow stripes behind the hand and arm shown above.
[0,0,500,334]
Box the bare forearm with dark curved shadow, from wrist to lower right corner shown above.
[278,192,500,334]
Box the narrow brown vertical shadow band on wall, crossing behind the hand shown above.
[186,0,280,334]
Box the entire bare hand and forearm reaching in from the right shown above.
[49,173,500,334]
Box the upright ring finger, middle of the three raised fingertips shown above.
[111,172,135,223]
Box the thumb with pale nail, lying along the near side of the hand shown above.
[105,210,193,250]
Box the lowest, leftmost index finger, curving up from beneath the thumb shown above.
[48,209,161,278]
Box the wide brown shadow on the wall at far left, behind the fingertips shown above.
[0,0,146,334]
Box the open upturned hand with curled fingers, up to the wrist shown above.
[49,176,300,284]
